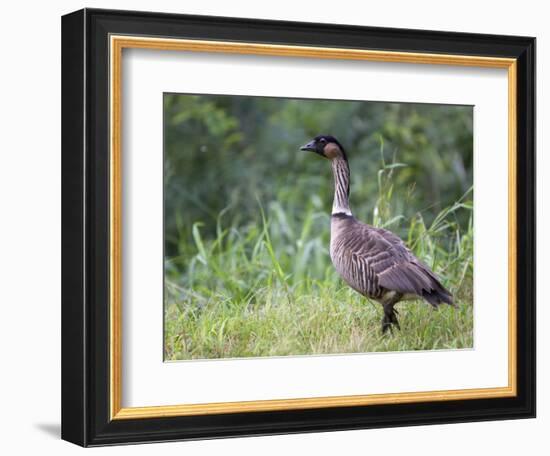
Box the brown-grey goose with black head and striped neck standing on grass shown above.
[300,135,454,333]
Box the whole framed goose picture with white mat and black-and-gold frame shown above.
[62,9,535,446]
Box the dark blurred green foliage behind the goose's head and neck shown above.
[164,94,473,257]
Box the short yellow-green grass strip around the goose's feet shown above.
[166,287,472,360]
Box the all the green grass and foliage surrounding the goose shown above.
[164,94,473,360]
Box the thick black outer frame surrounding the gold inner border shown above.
[61,9,535,446]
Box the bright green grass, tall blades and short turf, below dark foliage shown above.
[165,157,473,360]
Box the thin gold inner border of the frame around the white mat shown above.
[109,35,517,420]
